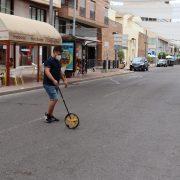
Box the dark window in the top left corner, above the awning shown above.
[0,0,13,14]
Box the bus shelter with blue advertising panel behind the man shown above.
[62,35,100,77]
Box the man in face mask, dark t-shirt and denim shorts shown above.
[43,46,67,123]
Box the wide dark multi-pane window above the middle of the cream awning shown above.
[29,6,46,22]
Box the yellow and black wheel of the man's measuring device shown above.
[64,113,79,129]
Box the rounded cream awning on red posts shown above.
[0,13,62,45]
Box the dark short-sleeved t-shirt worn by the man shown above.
[43,56,61,86]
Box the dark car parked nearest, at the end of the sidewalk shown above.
[130,57,149,71]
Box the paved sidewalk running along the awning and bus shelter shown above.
[0,69,130,96]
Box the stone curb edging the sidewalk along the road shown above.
[0,72,133,96]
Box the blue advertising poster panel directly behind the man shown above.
[62,42,74,71]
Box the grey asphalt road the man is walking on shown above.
[0,66,180,180]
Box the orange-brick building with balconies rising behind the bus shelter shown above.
[55,0,109,68]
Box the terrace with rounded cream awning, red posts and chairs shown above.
[0,13,62,86]
